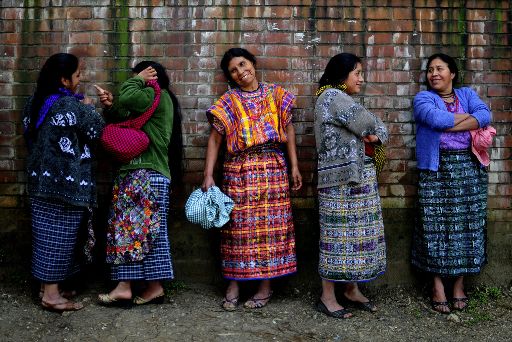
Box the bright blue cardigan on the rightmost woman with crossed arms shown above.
[413,87,491,171]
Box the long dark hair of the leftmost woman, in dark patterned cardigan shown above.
[27,53,79,141]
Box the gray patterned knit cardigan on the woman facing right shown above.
[315,88,388,189]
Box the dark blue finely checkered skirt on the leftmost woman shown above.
[31,197,87,283]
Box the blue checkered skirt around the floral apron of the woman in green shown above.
[111,171,174,281]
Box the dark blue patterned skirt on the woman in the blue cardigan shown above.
[411,150,487,276]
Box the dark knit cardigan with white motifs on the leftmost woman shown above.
[23,96,105,207]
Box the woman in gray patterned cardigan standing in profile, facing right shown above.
[315,53,388,318]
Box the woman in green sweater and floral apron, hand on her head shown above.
[98,61,181,306]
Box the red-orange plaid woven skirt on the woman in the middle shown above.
[221,146,297,280]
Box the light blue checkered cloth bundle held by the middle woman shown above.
[185,186,235,229]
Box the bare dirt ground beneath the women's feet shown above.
[0,282,512,342]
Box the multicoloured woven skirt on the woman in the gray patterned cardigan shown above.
[318,161,386,282]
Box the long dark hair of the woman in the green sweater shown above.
[132,61,183,187]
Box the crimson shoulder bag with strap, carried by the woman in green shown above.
[100,80,161,163]
